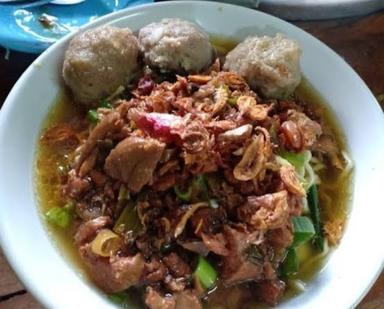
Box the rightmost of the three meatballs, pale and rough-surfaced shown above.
[224,34,301,99]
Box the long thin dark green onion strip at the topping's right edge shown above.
[307,185,324,251]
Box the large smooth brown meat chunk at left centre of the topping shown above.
[104,136,165,192]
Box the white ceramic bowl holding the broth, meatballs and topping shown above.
[0,2,384,309]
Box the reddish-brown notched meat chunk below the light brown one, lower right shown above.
[222,226,263,285]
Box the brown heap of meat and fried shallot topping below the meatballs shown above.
[42,61,343,309]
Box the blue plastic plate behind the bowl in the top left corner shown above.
[0,0,153,53]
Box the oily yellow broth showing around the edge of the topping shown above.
[35,36,351,309]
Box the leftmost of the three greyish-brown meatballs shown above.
[63,26,139,106]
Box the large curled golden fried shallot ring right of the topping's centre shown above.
[233,127,272,181]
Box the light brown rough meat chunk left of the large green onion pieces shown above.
[237,190,290,230]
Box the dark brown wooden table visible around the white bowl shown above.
[0,7,384,309]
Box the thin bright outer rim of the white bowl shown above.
[0,1,384,307]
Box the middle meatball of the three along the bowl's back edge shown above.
[139,18,214,73]
